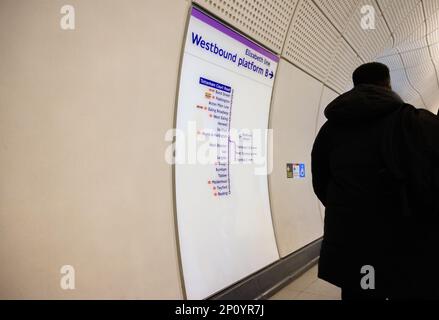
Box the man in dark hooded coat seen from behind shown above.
[312,63,439,299]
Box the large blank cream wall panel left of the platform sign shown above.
[0,0,189,299]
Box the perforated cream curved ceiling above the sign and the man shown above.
[194,0,439,111]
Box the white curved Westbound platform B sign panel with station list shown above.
[175,8,279,299]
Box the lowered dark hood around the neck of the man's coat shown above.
[325,85,404,123]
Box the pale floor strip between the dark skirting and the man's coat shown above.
[270,265,341,300]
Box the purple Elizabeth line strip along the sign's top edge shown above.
[192,8,279,62]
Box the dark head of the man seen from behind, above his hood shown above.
[352,62,392,89]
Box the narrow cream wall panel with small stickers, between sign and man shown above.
[269,59,323,257]
